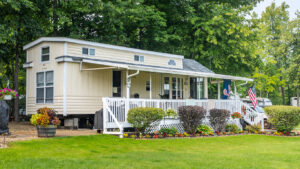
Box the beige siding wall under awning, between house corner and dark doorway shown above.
[67,63,112,114]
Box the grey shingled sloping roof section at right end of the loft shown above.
[182,59,214,73]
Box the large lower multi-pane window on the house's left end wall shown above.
[36,71,54,103]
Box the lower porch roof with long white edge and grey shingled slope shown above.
[56,56,253,81]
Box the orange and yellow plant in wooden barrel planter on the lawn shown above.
[30,107,60,137]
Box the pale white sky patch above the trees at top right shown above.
[254,0,300,19]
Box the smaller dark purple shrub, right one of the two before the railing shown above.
[209,109,230,132]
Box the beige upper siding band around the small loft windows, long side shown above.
[68,43,182,68]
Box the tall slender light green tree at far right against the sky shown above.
[261,3,292,104]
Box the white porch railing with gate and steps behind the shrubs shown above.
[102,98,261,134]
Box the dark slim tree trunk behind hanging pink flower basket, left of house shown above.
[14,44,20,121]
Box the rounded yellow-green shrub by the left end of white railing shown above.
[127,107,165,133]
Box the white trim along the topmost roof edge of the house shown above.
[23,37,184,59]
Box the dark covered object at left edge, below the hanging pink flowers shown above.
[0,100,9,134]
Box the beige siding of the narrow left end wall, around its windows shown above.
[26,42,64,114]
